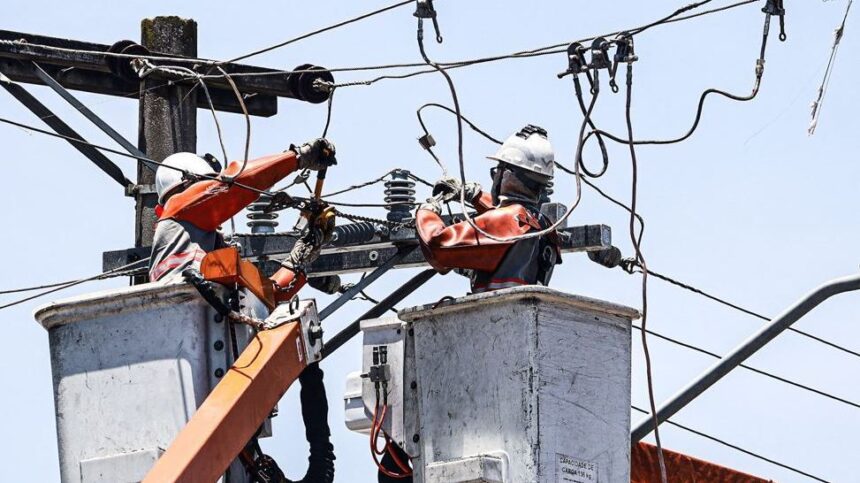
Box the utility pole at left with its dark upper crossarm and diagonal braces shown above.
[0,22,334,284]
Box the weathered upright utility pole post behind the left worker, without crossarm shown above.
[134,16,198,284]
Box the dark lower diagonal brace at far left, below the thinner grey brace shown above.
[0,70,134,189]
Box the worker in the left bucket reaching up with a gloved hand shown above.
[149,139,336,302]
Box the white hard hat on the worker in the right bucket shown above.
[487,124,555,181]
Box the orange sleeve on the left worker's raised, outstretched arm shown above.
[159,151,298,231]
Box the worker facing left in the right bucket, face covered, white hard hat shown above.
[415,125,561,293]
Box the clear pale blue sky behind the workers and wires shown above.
[0,0,860,482]
